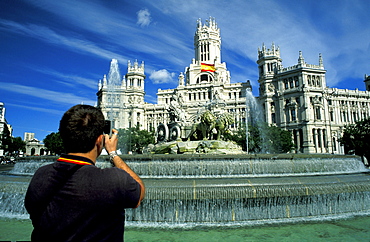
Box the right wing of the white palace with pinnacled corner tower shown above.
[257,44,370,153]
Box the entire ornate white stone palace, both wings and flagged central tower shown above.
[97,18,370,153]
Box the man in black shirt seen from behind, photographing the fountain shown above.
[25,105,145,241]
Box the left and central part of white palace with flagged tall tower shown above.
[97,19,251,140]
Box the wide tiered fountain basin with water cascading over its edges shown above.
[0,154,370,226]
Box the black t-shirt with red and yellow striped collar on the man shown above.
[25,155,140,241]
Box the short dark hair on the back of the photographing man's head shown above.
[59,104,104,153]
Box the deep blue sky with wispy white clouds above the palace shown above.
[0,0,370,140]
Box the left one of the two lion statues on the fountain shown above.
[188,111,216,140]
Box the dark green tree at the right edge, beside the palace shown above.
[339,118,370,164]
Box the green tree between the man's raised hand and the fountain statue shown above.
[118,126,155,154]
